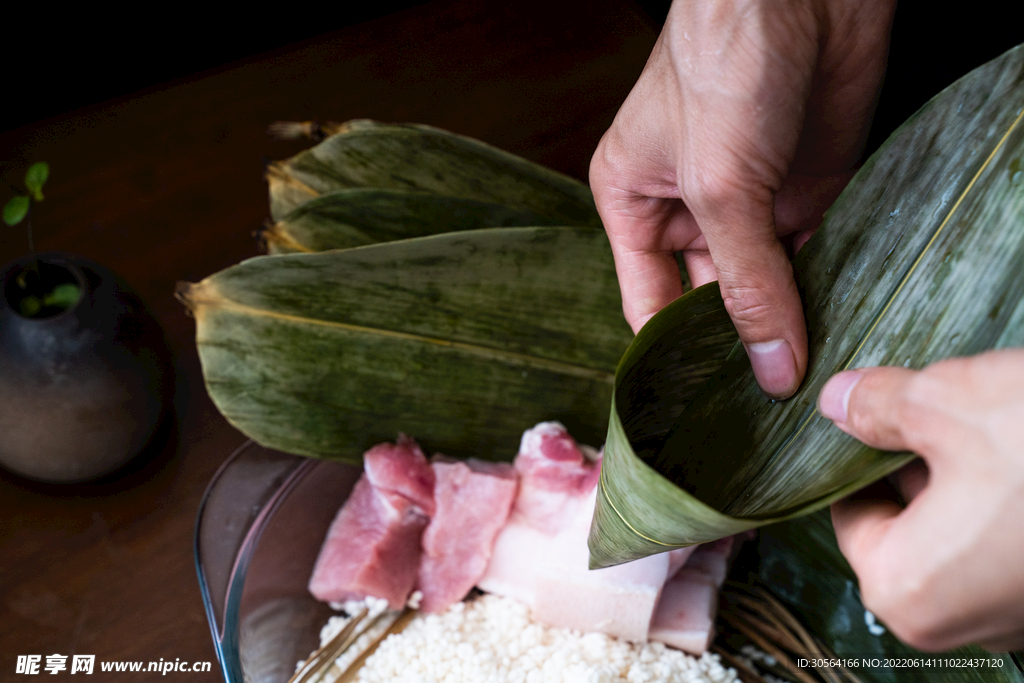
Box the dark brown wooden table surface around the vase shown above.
[0,0,656,681]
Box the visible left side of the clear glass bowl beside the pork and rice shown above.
[195,441,361,683]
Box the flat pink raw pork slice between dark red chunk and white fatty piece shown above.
[417,456,517,612]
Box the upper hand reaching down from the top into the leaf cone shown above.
[590,0,895,397]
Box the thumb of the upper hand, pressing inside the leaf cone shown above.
[698,199,807,398]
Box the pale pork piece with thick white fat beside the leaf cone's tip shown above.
[477,422,678,642]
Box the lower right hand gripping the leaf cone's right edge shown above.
[818,349,1024,651]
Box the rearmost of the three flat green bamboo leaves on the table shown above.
[266,121,601,226]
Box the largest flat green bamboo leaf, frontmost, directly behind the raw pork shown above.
[179,227,632,458]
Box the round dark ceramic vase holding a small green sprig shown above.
[0,253,173,482]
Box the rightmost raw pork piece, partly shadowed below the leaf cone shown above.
[648,537,733,654]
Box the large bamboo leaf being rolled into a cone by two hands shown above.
[591,41,1024,566]
